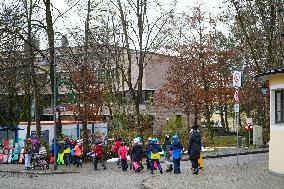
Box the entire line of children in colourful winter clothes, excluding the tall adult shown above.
[23,135,196,174]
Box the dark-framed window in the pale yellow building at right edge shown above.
[275,90,284,124]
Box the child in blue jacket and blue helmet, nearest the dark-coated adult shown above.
[171,135,183,174]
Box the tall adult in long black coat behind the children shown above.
[188,125,201,174]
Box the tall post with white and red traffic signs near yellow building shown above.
[233,71,242,165]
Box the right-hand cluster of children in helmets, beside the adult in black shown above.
[112,135,183,174]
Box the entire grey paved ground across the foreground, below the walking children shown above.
[0,153,284,189]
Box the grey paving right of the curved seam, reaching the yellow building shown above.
[143,153,284,189]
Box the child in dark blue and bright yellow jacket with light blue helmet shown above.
[148,138,163,174]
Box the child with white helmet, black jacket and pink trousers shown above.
[131,138,143,173]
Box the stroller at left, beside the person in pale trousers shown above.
[31,147,49,170]
